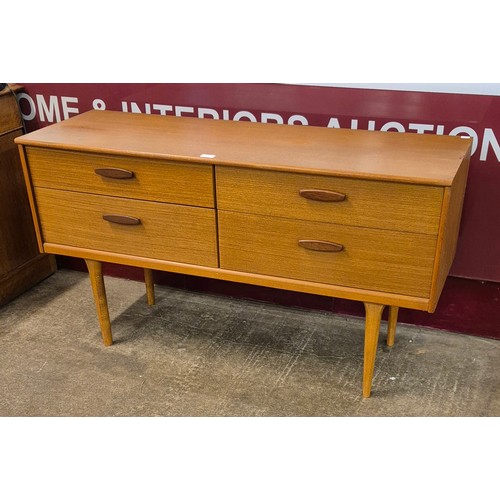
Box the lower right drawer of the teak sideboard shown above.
[219,211,437,298]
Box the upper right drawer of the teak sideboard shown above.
[216,167,443,234]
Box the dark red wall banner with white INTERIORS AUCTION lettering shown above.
[18,83,500,282]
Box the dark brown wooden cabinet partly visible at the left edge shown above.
[0,87,55,305]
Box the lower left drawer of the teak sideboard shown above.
[35,188,218,267]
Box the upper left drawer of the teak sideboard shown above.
[26,147,214,207]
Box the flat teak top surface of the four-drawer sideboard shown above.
[16,110,472,186]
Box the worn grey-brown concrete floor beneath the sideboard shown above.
[0,270,500,417]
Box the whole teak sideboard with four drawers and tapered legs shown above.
[16,111,472,397]
